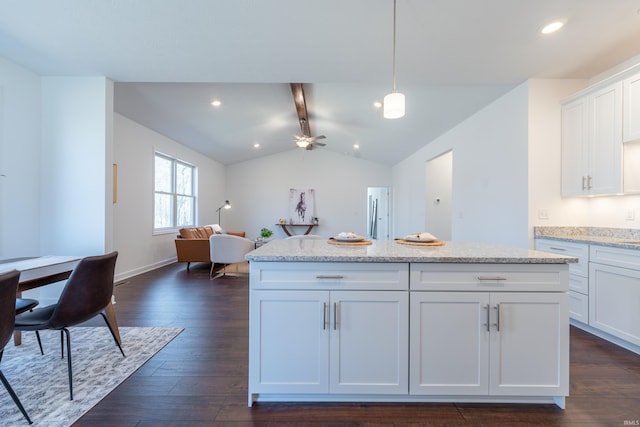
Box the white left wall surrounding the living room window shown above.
[113,114,226,280]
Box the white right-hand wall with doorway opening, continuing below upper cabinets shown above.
[393,75,640,252]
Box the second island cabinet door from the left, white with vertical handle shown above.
[330,291,409,394]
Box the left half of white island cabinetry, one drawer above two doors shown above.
[249,263,409,399]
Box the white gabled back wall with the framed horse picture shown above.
[228,148,393,239]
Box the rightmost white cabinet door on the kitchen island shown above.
[489,293,569,396]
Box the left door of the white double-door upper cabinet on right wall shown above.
[562,97,588,196]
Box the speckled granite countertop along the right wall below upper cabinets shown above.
[533,227,640,250]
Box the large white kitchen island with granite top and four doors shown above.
[246,240,576,408]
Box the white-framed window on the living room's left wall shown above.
[153,153,196,231]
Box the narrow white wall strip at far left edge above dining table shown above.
[0,58,41,259]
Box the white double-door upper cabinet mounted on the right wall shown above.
[562,82,622,196]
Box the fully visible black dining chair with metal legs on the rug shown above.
[15,252,125,400]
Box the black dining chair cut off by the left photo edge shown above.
[0,270,32,424]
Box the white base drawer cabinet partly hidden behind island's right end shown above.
[536,239,589,324]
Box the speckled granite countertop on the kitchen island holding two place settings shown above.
[245,239,578,264]
